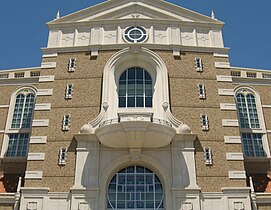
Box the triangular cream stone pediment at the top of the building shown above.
[49,0,223,25]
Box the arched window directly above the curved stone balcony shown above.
[118,67,152,107]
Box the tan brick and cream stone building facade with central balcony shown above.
[0,0,271,210]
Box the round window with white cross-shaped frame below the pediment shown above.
[124,26,148,43]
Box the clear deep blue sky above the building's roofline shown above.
[0,0,271,70]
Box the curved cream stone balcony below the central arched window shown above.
[95,113,176,149]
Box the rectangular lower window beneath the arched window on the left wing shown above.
[6,133,29,157]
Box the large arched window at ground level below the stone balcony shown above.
[107,166,164,210]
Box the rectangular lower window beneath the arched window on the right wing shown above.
[242,133,265,157]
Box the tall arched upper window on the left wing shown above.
[11,91,35,128]
